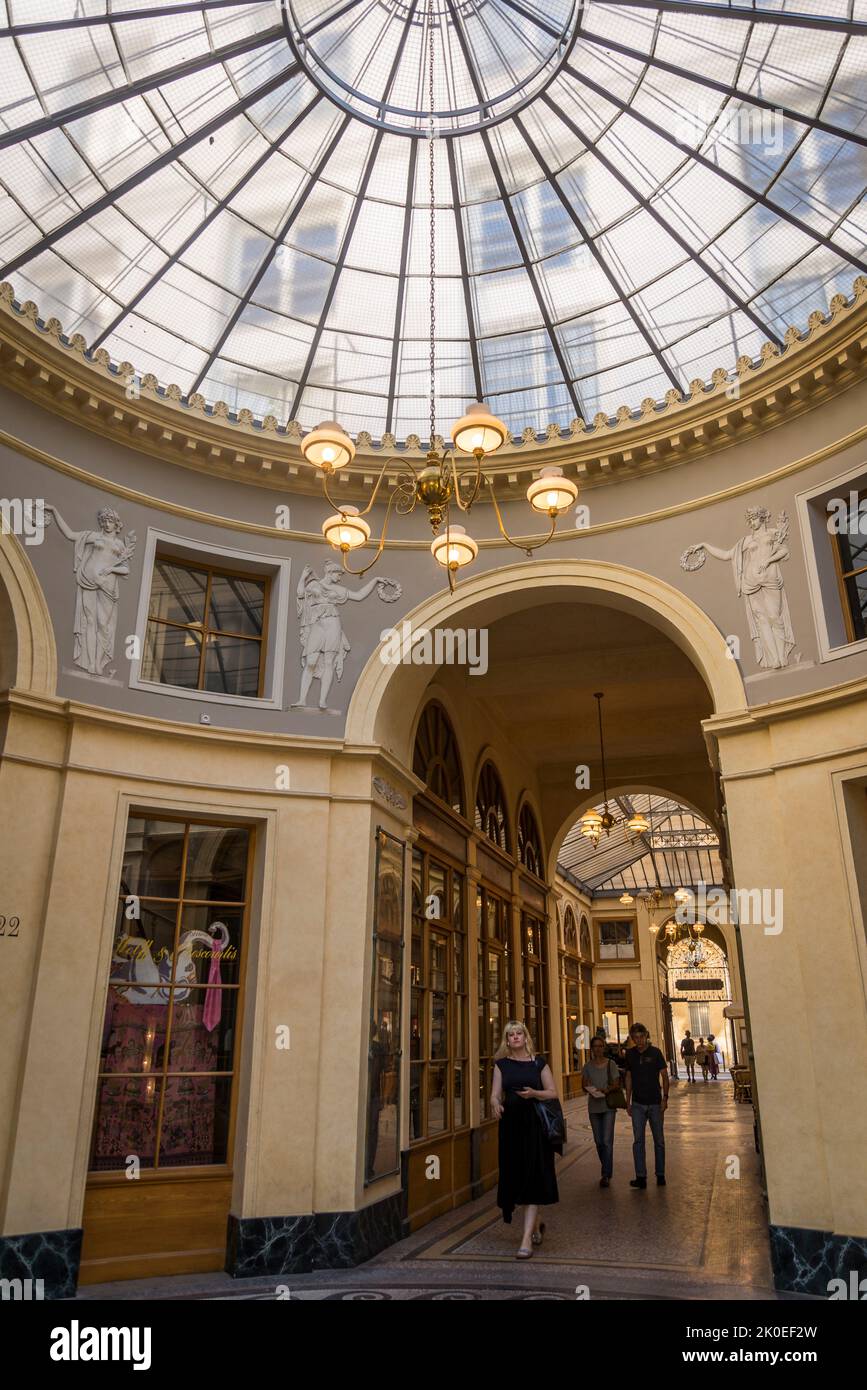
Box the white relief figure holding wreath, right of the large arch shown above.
[681,507,795,670]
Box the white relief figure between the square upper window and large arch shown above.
[292,560,402,709]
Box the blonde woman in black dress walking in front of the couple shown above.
[490,1022,560,1259]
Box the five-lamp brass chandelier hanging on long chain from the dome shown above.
[302,0,578,592]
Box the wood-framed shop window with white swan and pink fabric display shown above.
[79,812,254,1284]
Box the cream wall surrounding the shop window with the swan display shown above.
[0,695,411,1233]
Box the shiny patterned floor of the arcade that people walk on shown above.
[79,1077,778,1301]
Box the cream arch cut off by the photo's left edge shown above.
[0,527,57,695]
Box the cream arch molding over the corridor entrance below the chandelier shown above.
[346,559,746,766]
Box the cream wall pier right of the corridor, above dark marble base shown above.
[706,681,867,1236]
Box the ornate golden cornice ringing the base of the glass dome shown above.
[0,275,867,502]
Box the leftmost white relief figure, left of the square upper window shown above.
[44,505,136,676]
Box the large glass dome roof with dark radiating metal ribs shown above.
[0,0,867,436]
